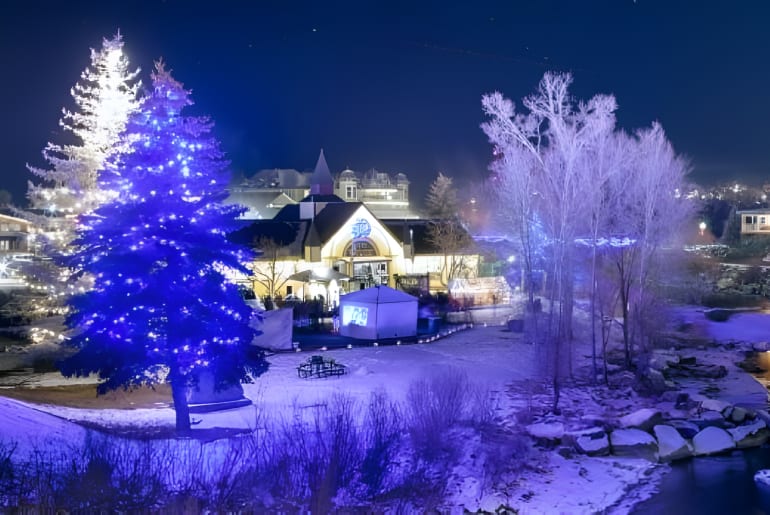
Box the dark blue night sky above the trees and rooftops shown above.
[0,0,770,203]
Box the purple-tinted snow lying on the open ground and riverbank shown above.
[0,309,770,513]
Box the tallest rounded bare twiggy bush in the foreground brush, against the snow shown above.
[406,368,470,460]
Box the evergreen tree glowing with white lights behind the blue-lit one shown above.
[27,33,141,230]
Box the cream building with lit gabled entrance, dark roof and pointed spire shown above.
[230,162,479,307]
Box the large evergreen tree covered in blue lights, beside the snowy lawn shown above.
[61,63,267,431]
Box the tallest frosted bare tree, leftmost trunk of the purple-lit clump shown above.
[482,72,616,410]
